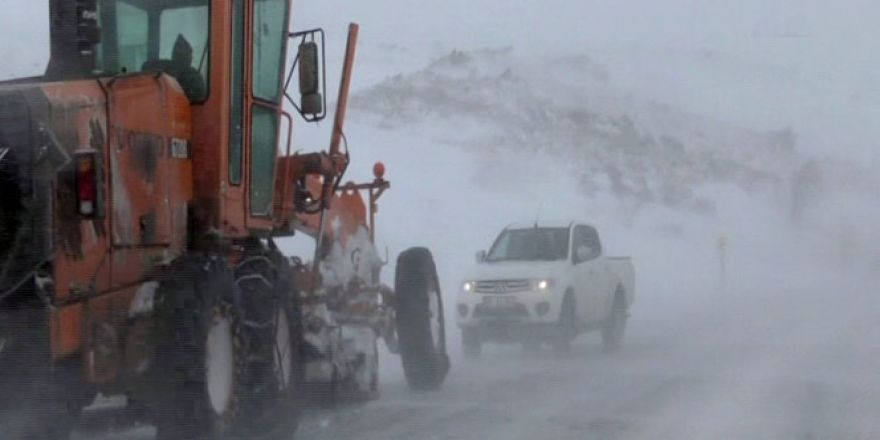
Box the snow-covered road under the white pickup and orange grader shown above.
[75,266,880,440]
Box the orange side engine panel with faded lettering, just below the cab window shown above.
[108,75,191,246]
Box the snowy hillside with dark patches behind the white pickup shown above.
[324,44,880,320]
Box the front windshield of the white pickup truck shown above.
[486,228,568,261]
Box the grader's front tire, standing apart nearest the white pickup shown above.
[394,247,449,390]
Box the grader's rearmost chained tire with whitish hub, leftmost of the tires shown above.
[154,257,249,440]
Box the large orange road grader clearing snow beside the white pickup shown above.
[0,0,449,439]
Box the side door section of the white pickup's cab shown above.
[571,225,611,326]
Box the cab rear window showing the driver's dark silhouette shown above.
[95,0,209,102]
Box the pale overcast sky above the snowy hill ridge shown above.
[294,0,880,160]
